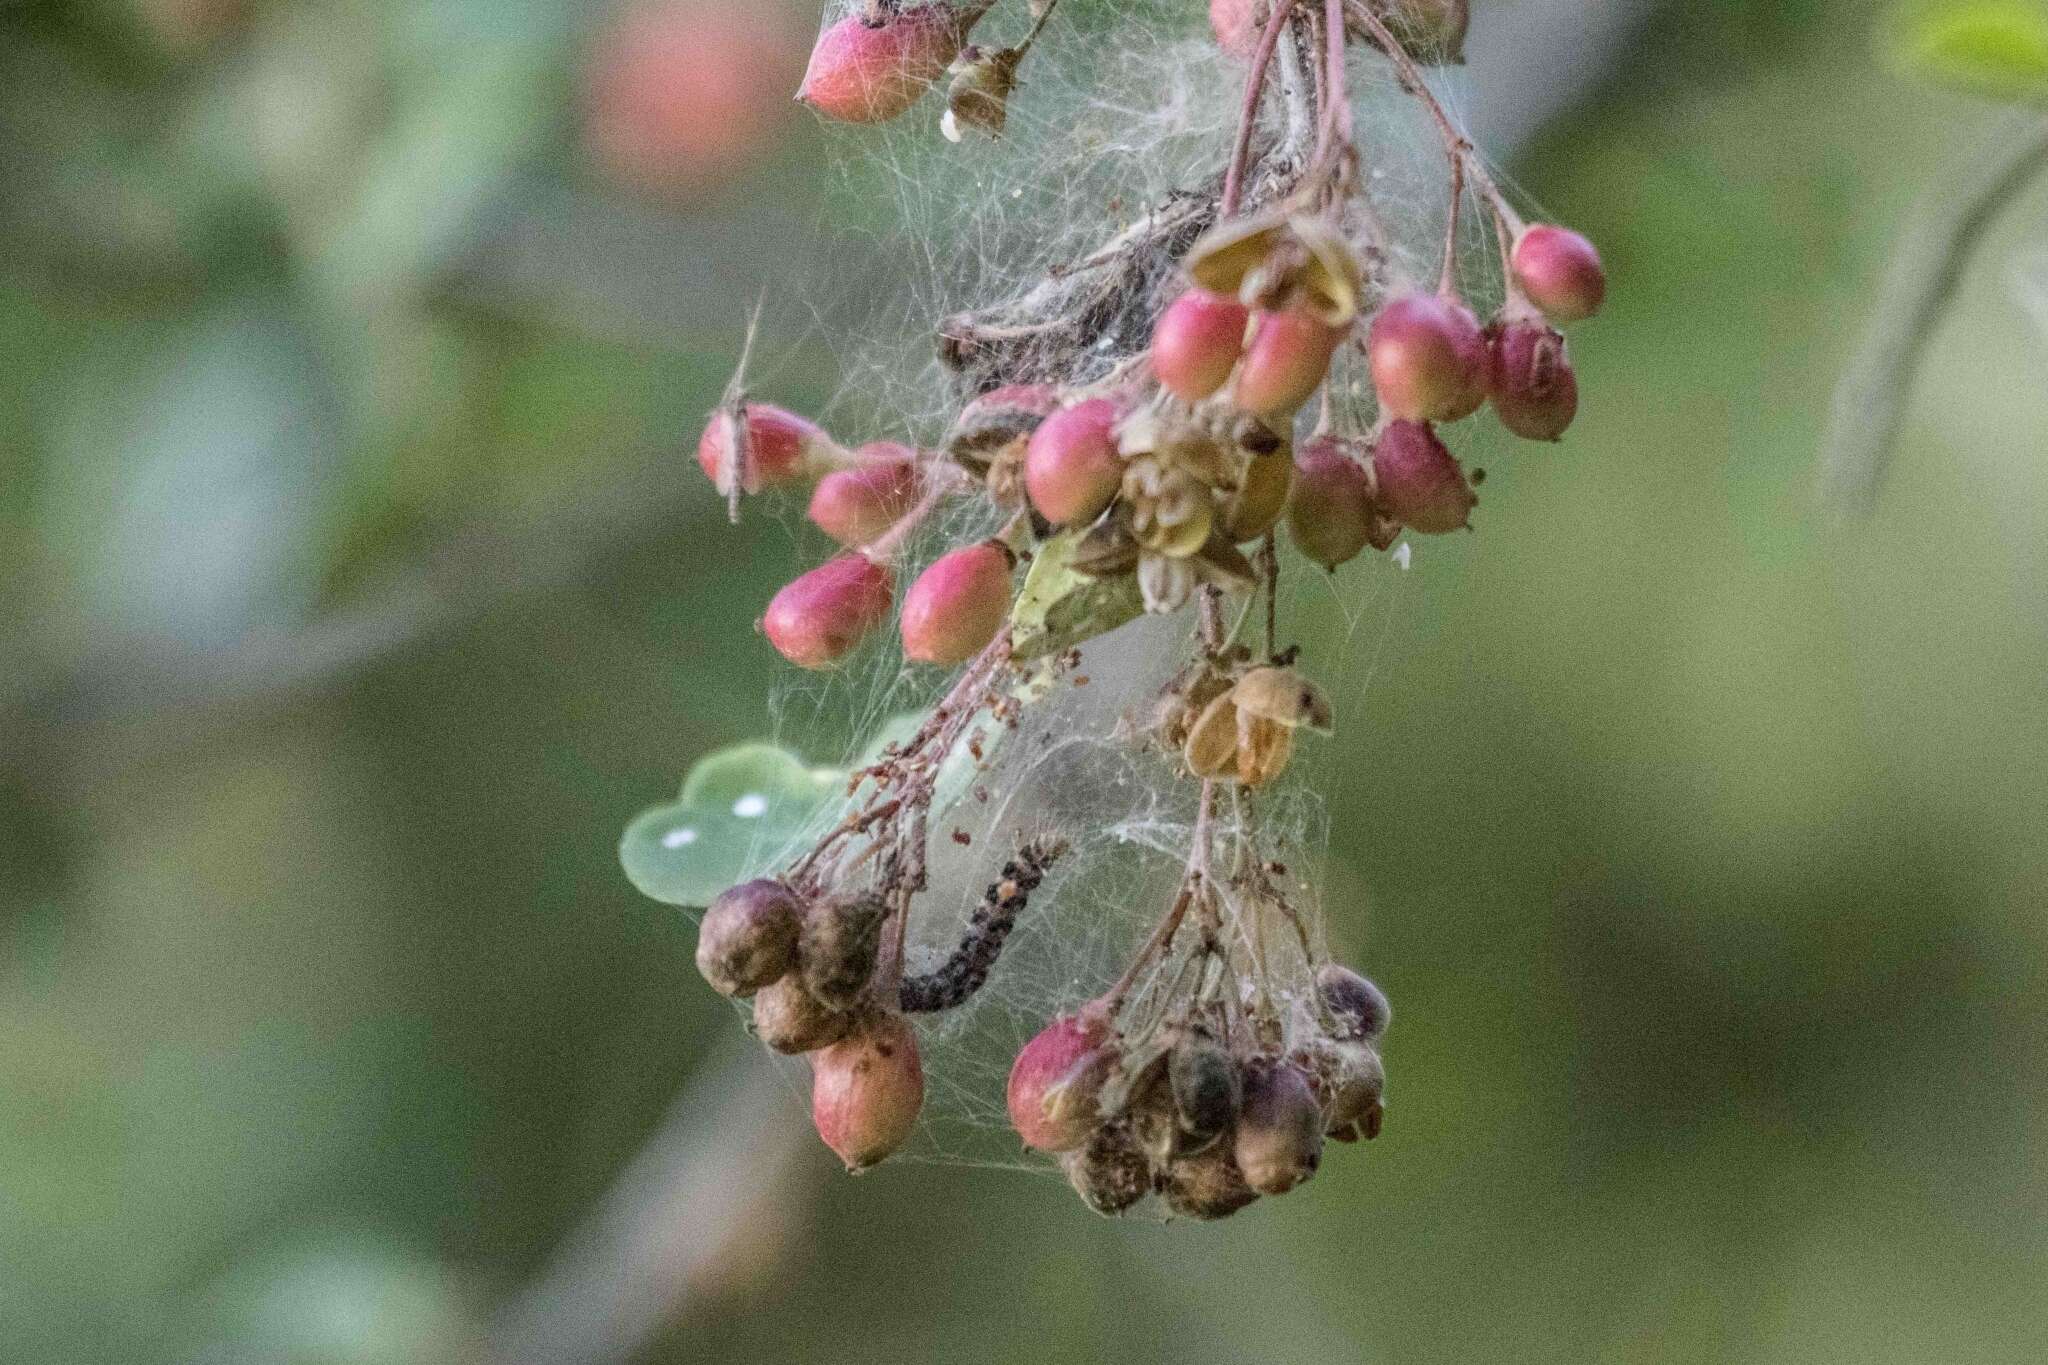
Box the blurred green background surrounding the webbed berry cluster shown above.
[0,0,2048,1365]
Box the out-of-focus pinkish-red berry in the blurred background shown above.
[584,0,803,194]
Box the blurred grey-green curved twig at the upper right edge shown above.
[1819,115,2048,520]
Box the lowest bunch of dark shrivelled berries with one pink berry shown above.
[1006,962,1391,1220]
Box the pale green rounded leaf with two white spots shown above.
[618,743,846,907]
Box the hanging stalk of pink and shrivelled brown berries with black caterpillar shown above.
[663,0,1606,1218]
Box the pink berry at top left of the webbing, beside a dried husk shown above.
[797,0,987,123]
